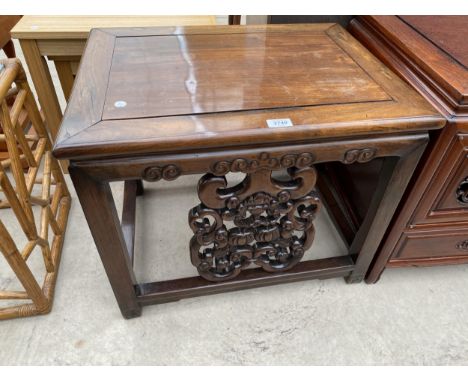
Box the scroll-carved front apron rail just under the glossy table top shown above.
[66,134,432,182]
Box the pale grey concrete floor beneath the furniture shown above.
[0,17,468,365]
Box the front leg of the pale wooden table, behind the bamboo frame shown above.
[20,40,68,173]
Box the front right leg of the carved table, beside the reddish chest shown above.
[346,134,428,283]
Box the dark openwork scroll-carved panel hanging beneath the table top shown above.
[189,153,321,281]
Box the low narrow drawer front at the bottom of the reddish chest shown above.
[392,225,468,260]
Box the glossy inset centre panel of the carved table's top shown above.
[102,32,391,120]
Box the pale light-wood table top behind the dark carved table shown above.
[11,16,216,39]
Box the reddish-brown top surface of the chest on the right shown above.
[363,16,468,110]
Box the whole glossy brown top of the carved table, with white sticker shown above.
[54,24,445,159]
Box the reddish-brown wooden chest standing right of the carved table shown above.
[350,16,468,282]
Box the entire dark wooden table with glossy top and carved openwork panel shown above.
[54,24,445,318]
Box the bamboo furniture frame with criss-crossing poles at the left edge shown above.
[0,59,71,319]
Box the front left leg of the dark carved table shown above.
[70,166,141,318]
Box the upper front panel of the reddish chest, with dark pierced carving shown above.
[412,127,468,224]
